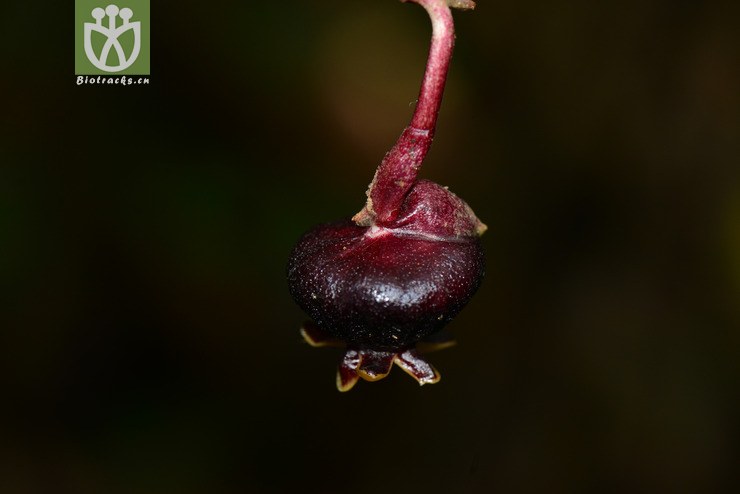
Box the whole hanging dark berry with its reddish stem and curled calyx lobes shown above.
[288,0,486,391]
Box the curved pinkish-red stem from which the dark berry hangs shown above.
[352,0,468,226]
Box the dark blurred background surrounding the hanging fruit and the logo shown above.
[0,0,740,494]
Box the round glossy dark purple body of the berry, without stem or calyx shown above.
[288,182,483,351]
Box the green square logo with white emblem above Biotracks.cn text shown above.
[75,0,150,75]
